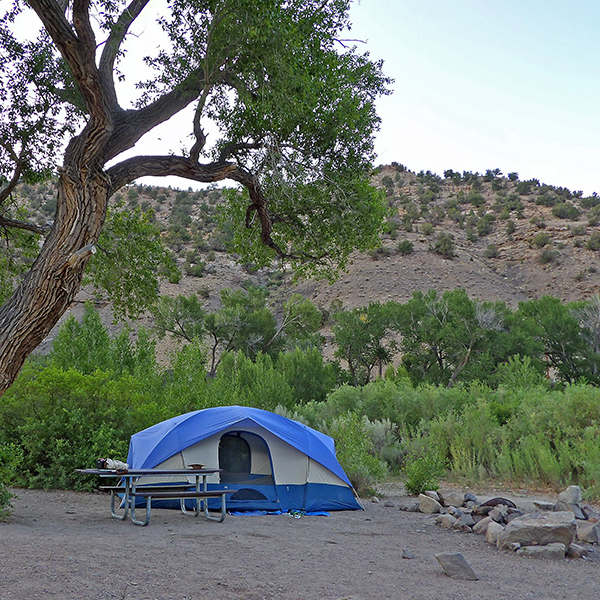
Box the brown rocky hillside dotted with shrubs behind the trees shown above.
[19,163,600,352]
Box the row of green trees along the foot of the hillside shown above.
[156,288,600,387]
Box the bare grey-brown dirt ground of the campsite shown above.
[0,486,600,600]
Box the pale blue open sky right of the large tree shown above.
[351,0,600,195]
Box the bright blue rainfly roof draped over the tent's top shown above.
[127,406,351,485]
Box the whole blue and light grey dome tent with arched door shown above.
[127,406,362,512]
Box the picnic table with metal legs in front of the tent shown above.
[75,467,233,527]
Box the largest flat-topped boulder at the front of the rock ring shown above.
[497,511,577,550]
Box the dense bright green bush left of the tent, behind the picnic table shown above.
[0,366,149,489]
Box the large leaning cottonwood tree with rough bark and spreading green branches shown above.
[0,0,388,394]
